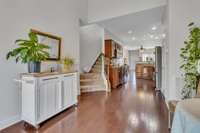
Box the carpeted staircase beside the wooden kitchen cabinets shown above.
[80,55,106,93]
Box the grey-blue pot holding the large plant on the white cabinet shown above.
[28,61,41,73]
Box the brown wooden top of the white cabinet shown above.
[21,70,78,77]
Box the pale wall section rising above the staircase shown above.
[80,24,104,72]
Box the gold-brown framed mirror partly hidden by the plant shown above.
[31,29,61,61]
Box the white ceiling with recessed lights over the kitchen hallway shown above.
[98,6,165,49]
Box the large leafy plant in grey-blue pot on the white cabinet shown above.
[6,32,49,73]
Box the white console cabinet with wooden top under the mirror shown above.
[22,72,78,128]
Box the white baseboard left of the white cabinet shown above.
[0,115,21,131]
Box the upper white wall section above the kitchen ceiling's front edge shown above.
[88,0,166,22]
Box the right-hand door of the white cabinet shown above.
[63,74,74,108]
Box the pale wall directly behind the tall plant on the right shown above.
[163,0,200,99]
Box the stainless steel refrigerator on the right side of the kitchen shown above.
[155,46,162,91]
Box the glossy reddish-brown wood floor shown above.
[1,74,168,133]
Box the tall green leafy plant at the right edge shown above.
[180,23,200,99]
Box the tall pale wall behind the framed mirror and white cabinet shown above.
[0,0,87,129]
